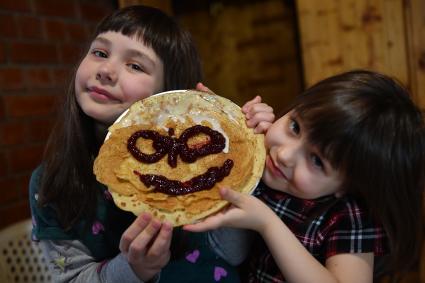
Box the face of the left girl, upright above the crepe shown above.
[75,32,164,125]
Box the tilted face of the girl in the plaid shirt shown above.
[263,111,342,199]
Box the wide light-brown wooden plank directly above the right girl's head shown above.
[297,0,408,86]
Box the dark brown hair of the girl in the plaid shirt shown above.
[291,70,425,278]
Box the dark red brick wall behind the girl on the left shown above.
[0,0,116,231]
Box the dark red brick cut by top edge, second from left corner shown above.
[34,0,76,18]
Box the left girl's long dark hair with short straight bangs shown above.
[39,6,202,229]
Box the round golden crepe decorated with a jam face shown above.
[94,90,265,226]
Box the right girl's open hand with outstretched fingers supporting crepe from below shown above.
[183,188,276,232]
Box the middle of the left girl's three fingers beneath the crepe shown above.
[127,219,161,262]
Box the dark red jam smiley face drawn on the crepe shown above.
[127,125,233,195]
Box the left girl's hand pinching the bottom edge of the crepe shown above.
[119,213,173,282]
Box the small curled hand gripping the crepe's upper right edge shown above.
[242,96,275,134]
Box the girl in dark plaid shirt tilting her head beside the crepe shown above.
[185,70,425,282]
